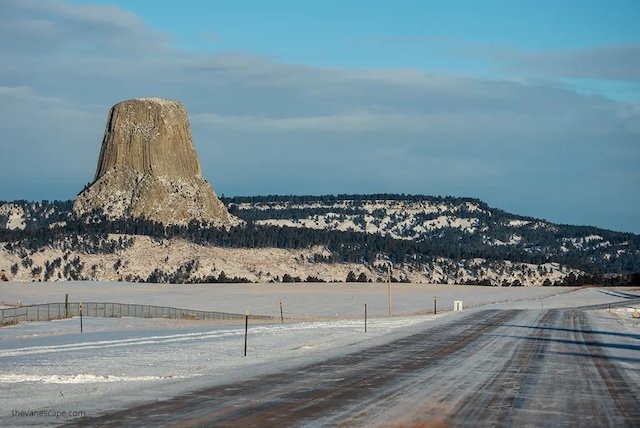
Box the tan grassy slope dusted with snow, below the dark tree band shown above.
[0,235,580,285]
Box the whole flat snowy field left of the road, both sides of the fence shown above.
[0,283,640,426]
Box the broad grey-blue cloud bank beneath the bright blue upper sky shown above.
[0,0,640,232]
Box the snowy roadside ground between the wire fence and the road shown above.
[0,315,446,426]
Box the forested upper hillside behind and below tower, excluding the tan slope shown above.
[0,194,640,283]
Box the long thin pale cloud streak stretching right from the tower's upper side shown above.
[191,106,640,136]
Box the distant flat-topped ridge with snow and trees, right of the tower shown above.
[225,195,640,272]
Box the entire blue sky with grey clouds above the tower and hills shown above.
[0,0,640,233]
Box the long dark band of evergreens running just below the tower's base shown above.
[0,212,640,274]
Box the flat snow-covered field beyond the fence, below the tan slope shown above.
[0,282,573,318]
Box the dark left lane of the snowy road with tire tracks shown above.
[66,310,521,428]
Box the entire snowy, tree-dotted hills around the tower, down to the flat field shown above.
[0,195,640,285]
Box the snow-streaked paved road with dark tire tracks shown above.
[67,309,640,428]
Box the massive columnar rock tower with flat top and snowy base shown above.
[73,98,237,225]
